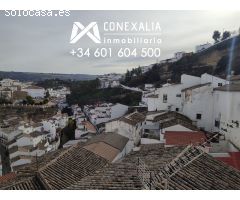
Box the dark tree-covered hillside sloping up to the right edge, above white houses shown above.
[122,31,240,87]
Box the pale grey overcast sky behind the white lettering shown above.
[0,11,240,74]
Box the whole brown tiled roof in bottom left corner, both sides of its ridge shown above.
[0,144,108,190]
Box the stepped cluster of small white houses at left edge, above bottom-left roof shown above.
[0,112,68,171]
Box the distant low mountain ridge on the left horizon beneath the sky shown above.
[0,71,97,82]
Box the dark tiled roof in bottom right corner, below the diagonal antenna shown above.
[165,154,240,190]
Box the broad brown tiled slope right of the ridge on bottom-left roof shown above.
[39,144,107,189]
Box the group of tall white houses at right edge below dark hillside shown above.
[141,73,240,151]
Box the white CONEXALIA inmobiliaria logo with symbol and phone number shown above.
[70,21,162,58]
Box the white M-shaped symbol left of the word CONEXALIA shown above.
[70,22,101,44]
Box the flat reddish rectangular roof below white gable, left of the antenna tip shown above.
[165,131,207,146]
